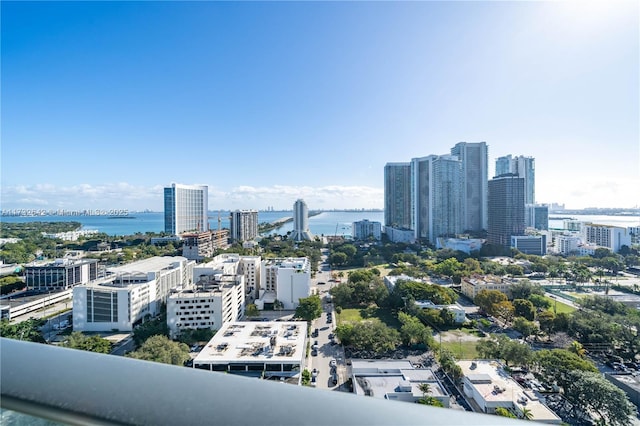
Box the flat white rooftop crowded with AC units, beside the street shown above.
[194,321,307,364]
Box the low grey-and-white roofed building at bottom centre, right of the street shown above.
[351,359,450,407]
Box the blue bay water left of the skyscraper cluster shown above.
[0,211,384,235]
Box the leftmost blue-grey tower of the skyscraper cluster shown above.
[384,163,411,229]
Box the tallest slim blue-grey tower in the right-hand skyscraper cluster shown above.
[451,142,489,232]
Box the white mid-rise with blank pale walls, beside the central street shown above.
[255,257,311,310]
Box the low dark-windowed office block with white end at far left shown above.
[24,259,98,291]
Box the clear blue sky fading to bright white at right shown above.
[0,1,640,210]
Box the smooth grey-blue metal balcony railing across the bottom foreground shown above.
[0,338,520,426]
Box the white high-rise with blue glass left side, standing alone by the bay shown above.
[164,183,209,235]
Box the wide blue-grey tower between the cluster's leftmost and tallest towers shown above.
[411,155,463,244]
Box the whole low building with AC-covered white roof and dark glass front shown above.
[193,321,307,384]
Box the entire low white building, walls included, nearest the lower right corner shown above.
[457,360,562,424]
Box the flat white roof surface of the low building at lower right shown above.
[457,360,560,423]
